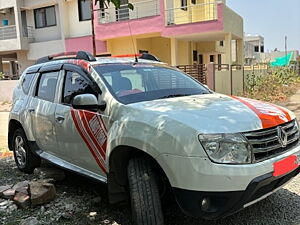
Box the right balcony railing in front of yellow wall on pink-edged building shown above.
[166,2,218,26]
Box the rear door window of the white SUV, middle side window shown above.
[36,72,59,102]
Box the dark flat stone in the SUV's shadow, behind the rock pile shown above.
[33,167,66,181]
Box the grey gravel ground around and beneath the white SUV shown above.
[0,158,300,225]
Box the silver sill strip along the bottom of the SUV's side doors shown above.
[36,150,107,183]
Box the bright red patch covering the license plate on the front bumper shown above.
[273,155,299,177]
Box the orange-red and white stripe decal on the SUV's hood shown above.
[231,96,291,129]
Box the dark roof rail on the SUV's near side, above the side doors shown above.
[36,51,96,64]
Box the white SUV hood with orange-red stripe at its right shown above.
[130,94,295,133]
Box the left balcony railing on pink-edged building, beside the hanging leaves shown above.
[98,0,160,24]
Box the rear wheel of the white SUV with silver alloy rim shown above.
[12,128,41,173]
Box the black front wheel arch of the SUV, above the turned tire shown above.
[107,145,170,203]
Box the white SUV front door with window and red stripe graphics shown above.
[55,65,107,180]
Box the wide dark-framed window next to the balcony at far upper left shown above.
[34,6,56,28]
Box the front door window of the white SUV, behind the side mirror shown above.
[62,71,98,104]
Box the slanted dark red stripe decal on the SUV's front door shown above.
[71,109,106,172]
